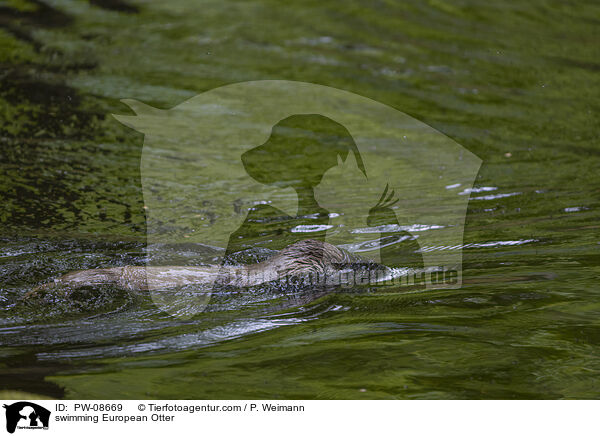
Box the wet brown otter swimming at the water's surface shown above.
[25,239,390,298]
